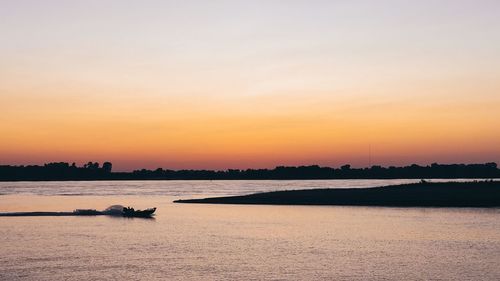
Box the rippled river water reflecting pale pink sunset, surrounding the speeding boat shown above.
[0,180,500,280]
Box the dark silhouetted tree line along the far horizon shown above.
[0,162,500,181]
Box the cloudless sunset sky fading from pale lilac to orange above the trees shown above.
[0,0,500,171]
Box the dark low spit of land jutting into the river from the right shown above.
[174,181,500,208]
